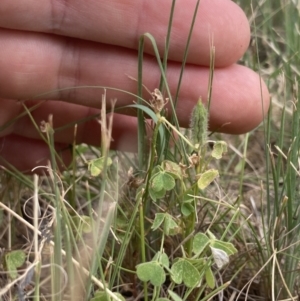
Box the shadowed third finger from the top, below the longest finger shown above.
[0,100,141,152]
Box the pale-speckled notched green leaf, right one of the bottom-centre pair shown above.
[171,258,201,288]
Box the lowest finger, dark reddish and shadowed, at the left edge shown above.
[0,135,72,173]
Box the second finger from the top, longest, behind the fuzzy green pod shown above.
[0,31,269,133]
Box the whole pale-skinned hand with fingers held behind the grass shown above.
[0,0,269,171]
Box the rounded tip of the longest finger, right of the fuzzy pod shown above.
[210,65,270,134]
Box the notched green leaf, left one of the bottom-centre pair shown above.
[136,261,166,286]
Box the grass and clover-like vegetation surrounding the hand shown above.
[0,0,300,301]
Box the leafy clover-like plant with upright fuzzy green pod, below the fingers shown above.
[111,89,237,301]
